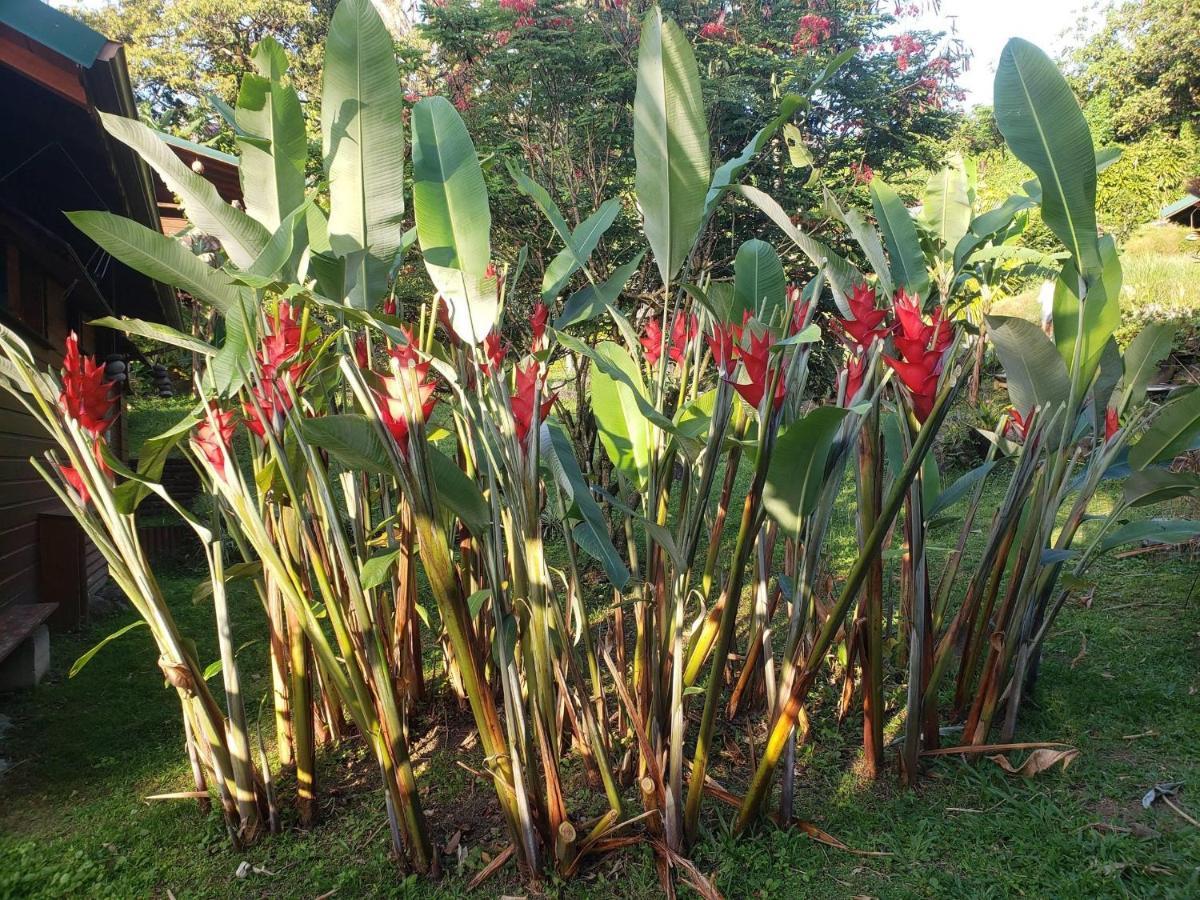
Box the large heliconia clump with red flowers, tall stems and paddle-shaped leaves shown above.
[0,0,1200,895]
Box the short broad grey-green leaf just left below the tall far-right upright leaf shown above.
[988,316,1070,416]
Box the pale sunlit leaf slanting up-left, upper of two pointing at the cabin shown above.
[100,113,270,266]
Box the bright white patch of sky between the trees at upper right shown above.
[918,0,1094,108]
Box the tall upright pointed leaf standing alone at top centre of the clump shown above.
[634,6,710,289]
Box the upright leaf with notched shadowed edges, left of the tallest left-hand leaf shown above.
[234,37,308,232]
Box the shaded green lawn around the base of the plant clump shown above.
[7,468,1200,898]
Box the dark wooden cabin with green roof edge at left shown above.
[0,0,240,688]
